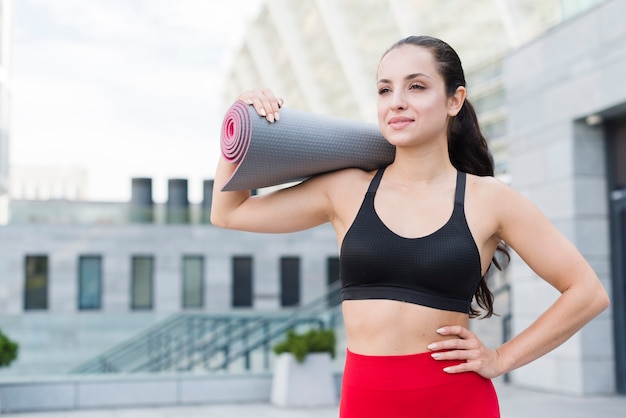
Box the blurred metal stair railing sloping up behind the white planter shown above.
[70,283,340,374]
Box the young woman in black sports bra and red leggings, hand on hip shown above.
[211,36,609,418]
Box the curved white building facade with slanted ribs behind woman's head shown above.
[223,0,603,177]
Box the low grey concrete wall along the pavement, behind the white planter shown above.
[0,373,342,412]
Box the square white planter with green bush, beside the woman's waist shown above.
[270,328,337,406]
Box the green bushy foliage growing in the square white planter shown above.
[274,328,336,363]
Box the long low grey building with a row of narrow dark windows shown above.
[0,178,339,375]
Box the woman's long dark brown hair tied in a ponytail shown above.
[383,36,510,318]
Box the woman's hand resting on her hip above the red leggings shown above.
[428,325,504,379]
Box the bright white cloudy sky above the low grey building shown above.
[10,0,262,202]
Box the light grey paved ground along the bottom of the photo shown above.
[2,384,626,418]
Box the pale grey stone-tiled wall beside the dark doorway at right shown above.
[505,0,626,394]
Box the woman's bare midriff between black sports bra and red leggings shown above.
[342,299,468,356]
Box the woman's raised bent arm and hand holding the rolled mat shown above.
[211,89,330,233]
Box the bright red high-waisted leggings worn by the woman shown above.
[339,350,500,418]
